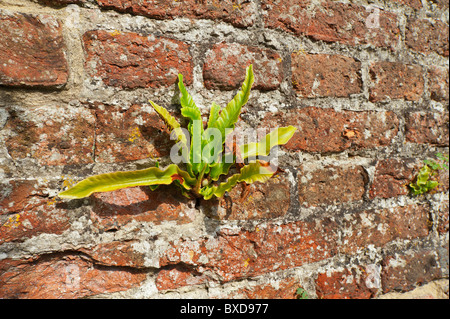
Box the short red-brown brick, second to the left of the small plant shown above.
[298,165,368,206]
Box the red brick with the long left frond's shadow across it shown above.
[91,185,195,231]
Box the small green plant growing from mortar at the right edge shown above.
[409,153,448,195]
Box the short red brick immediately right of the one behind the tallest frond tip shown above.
[291,52,362,97]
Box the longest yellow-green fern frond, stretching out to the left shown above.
[58,164,196,198]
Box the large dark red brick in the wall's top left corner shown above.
[0,10,68,88]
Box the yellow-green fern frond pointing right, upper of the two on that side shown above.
[239,126,297,159]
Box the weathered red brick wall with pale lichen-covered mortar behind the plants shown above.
[0,0,449,298]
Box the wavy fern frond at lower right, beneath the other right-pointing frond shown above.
[204,161,277,200]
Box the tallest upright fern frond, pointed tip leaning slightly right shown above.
[212,65,255,143]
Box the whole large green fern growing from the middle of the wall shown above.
[59,65,296,200]
